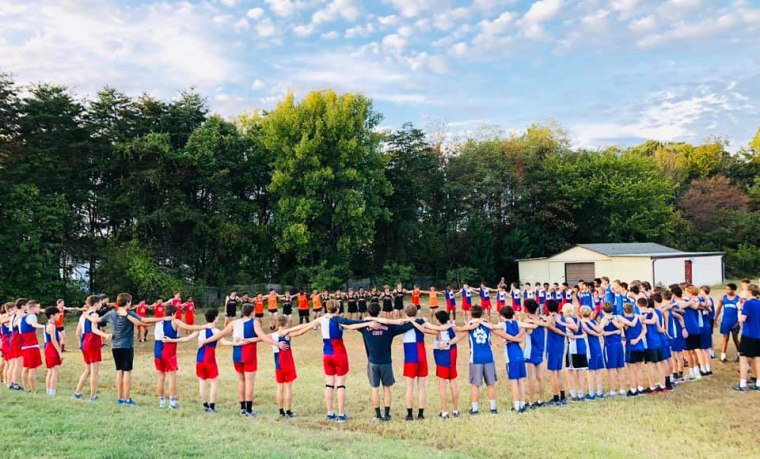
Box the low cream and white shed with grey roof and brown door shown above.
[518,242,723,286]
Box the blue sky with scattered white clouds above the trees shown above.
[0,0,760,149]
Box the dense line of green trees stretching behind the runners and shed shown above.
[0,75,760,306]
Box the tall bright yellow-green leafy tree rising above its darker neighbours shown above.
[263,91,391,282]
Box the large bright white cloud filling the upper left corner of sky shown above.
[0,1,238,96]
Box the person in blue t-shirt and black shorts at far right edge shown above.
[734,284,760,392]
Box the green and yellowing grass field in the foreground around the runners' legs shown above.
[0,298,760,458]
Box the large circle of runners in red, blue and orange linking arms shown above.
[0,278,760,423]
